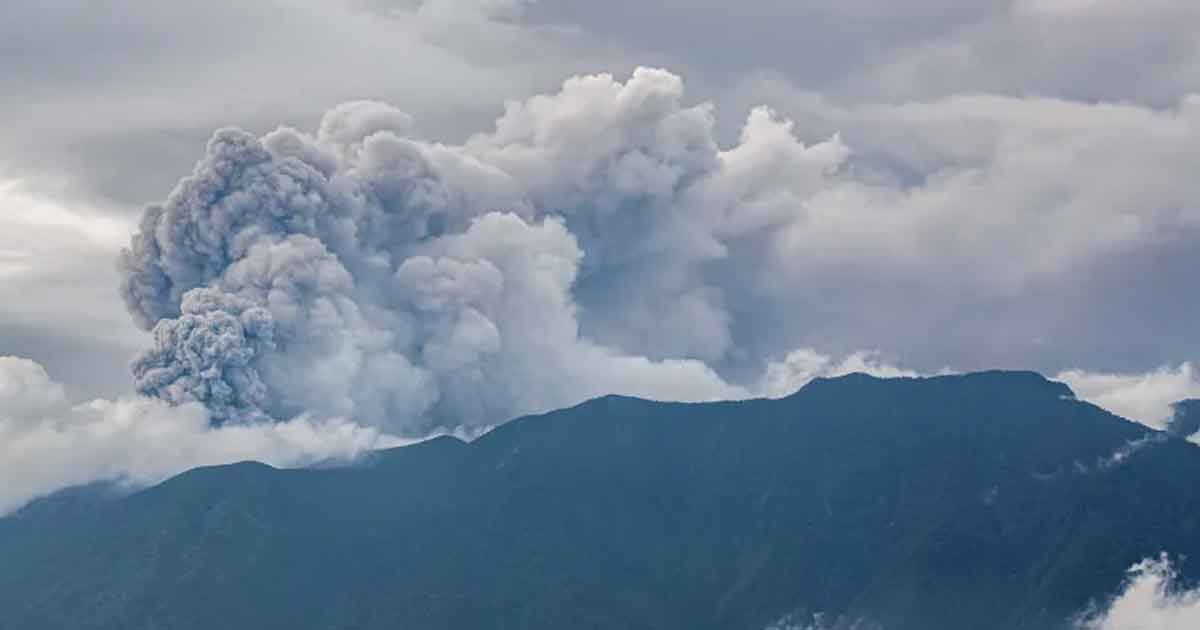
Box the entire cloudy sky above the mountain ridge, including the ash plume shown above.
[7,0,1200,520]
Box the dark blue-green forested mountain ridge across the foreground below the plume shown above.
[0,372,1200,630]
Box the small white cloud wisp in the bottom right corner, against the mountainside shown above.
[1076,556,1200,630]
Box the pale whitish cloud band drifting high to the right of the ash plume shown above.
[724,84,1200,295]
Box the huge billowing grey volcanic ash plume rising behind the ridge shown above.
[121,68,846,434]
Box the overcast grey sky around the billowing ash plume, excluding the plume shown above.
[0,0,1200,398]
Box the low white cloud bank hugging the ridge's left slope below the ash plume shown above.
[0,356,402,516]
